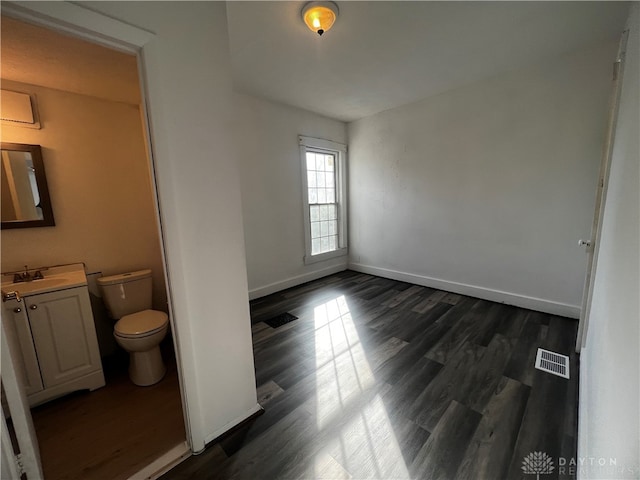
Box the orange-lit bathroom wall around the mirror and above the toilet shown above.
[0,80,167,310]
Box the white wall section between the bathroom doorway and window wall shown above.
[76,2,258,450]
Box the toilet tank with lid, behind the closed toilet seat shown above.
[98,269,152,319]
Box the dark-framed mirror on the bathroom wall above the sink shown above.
[0,142,55,229]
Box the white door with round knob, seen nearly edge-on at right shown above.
[576,30,629,353]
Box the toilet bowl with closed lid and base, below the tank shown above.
[113,310,169,387]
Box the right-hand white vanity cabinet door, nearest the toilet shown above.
[25,287,102,388]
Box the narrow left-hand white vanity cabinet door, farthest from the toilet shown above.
[2,300,43,395]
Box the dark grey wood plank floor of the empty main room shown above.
[162,271,578,480]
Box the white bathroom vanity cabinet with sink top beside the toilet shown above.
[2,264,105,406]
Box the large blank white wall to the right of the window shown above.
[348,44,615,316]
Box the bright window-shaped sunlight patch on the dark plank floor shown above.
[314,296,409,478]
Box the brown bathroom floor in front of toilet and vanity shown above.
[31,349,186,480]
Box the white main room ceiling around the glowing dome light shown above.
[227,0,629,121]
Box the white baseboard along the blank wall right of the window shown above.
[349,263,580,318]
